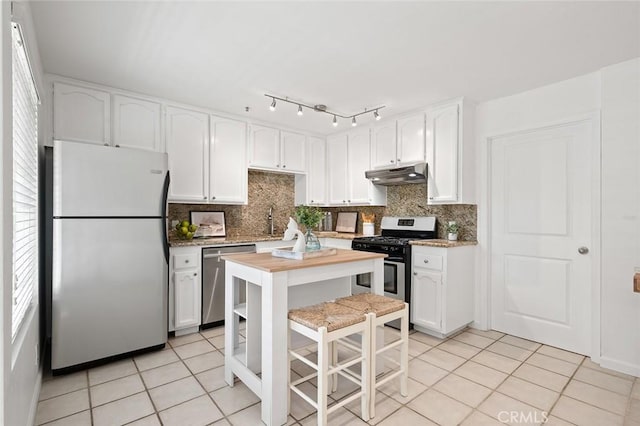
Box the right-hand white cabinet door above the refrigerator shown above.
[112,95,162,151]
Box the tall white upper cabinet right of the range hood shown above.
[427,100,475,204]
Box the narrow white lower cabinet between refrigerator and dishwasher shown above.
[169,247,202,335]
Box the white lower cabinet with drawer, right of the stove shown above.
[411,246,475,338]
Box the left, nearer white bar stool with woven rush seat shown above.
[288,302,371,426]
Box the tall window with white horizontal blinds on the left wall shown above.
[11,23,38,338]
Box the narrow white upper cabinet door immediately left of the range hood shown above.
[347,129,373,204]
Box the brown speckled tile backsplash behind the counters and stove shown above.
[169,170,477,241]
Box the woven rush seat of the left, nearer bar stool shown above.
[289,302,365,332]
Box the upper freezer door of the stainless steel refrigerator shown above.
[53,141,167,217]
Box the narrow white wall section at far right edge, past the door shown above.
[601,58,640,376]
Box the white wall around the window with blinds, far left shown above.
[0,2,44,425]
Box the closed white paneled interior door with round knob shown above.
[491,121,594,354]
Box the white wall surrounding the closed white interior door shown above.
[475,60,640,375]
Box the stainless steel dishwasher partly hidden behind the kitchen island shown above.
[200,244,256,328]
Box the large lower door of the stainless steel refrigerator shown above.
[51,219,168,370]
